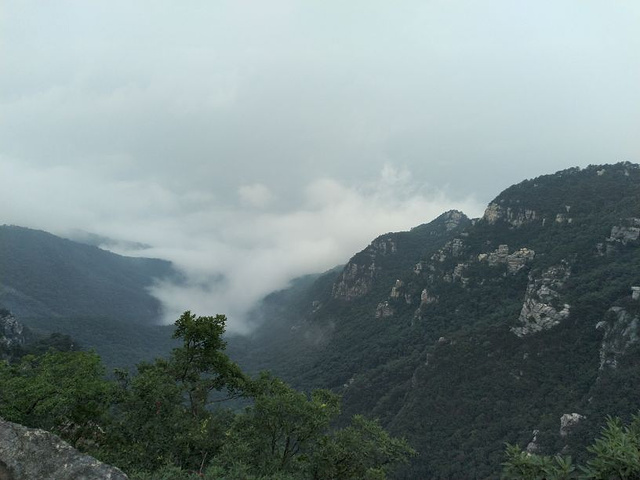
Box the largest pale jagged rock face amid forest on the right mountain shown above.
[511,264,570,337]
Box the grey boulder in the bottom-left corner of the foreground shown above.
[0,419,128,480]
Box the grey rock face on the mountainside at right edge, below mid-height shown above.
[596,307,640,370]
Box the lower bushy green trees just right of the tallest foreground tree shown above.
[218,374,415,480]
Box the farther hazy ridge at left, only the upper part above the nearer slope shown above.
[0,225,176,323]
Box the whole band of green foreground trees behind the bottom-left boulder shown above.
[0,312,415,480]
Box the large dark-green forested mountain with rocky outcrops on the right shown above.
[230,163,640,479]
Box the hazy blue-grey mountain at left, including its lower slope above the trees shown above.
[0,225,180,367]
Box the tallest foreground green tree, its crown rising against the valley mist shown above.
[102,311,249,471]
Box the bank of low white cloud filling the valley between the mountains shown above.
[0,158,482,334]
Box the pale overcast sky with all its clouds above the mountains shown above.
[0,0,640,333]
